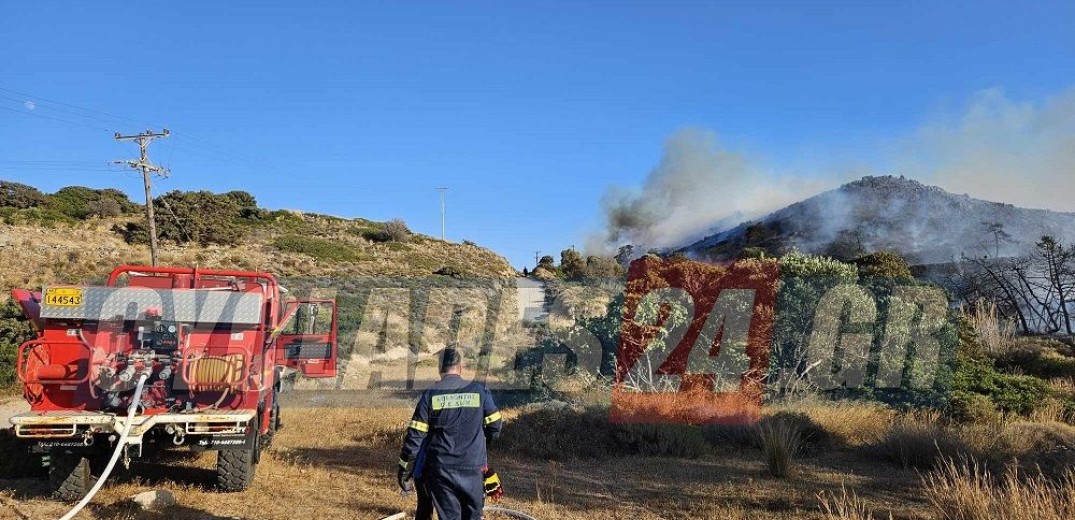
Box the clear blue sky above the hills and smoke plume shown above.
[0,0,1075,266]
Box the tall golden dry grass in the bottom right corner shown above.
[923,460,1075,520]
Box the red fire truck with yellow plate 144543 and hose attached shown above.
[11,265,336,500]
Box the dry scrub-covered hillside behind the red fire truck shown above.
[0,183,514,289]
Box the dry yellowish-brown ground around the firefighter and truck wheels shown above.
[0,405,929,520]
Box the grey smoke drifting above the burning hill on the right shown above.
[587,88,1075,251]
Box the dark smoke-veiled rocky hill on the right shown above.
[679,176,1075,263]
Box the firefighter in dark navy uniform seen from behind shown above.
[397,347,504,520]
